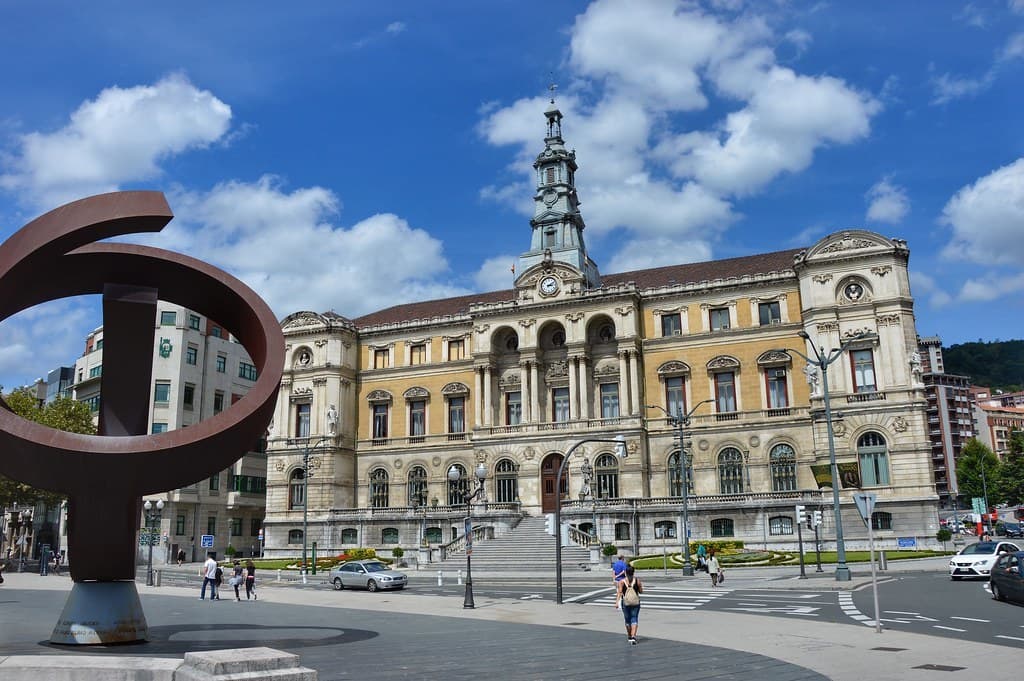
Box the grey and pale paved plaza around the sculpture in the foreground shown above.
[0,558,1021,681]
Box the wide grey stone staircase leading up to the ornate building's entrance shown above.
[435,516,602,573]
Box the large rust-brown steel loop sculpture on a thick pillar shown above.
[0,191,285,643]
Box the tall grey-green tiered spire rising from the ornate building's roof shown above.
[519,86,601,293]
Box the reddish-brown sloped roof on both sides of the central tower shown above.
[352,249,803,329]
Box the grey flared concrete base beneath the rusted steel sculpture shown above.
[50,582,150,645]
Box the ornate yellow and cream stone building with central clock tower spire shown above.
[265,100,937,556]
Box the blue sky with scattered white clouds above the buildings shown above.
[0,0,1024,388]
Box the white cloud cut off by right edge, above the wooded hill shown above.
[941,159,1024,266]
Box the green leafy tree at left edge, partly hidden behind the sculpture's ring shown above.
[0,388,96,508]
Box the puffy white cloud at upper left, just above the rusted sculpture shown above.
[0,74,231,208]
